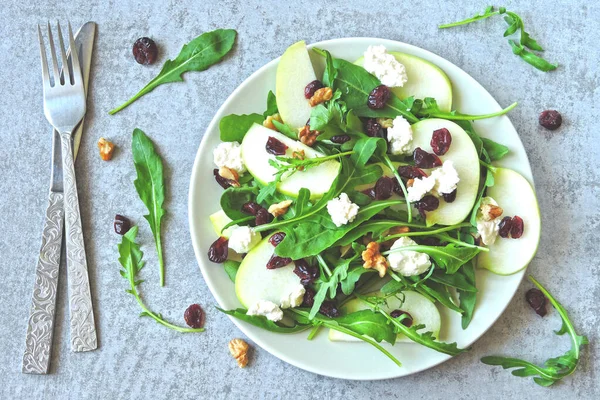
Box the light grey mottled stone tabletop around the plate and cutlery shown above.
[0,0,600,399]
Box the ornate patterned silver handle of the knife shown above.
[22,192,64,374]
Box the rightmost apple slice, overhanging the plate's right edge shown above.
[477,168,541,275]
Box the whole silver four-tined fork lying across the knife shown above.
[38,23,98,352]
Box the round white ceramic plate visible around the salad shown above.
[189,38,533,380]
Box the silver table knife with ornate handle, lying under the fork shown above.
[22,22,96,374]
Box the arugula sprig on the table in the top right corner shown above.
[438,6,558,72]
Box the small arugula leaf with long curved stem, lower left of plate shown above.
[118,225,204,332]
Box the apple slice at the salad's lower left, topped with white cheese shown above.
[235,236,300,308]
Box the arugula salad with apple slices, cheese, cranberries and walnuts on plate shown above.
[208,41,540,365]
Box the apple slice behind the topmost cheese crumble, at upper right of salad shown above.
[355,51,452,112]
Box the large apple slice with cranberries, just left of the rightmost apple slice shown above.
[412,118,480,226]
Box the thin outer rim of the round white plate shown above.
[188,36,535,381]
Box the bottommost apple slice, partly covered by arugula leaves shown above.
[329,291,442,342]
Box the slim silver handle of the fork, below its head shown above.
[60,132,98,352]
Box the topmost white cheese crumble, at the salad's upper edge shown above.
[363,46,408,87]
